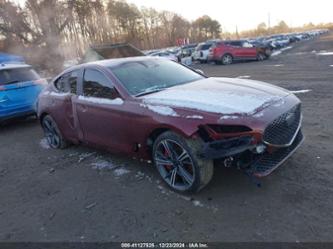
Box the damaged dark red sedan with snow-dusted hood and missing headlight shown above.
[38,57,303,192]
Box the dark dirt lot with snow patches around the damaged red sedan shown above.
[0,35,333,242]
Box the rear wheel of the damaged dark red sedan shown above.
[41,115,69,149]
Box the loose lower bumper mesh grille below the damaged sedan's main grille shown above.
[250,130,303,176]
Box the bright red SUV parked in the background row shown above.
[208,40,266,65]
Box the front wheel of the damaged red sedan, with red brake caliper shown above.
[153,131,214,193]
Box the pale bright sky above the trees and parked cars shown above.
[15,0,333,32]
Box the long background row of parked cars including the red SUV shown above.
[142,30,328,65]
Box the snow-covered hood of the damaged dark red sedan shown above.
[142,78,291,115]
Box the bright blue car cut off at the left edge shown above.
[0,64,47,122]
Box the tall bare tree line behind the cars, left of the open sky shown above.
[0,0,221,71]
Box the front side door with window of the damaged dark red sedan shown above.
[75,68,124,150]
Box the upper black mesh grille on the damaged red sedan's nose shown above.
[263,104,301,145]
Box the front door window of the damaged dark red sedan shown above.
[83,69,118,99]
